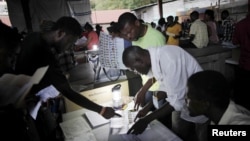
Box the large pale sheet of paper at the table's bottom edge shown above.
[60,117,96,141]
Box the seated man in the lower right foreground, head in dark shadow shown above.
[186,70,250,125]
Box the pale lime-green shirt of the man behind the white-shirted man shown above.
[132,24,166,91]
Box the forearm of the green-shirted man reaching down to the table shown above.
[134,78,156,110]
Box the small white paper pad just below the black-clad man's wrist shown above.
[85,111,109,128]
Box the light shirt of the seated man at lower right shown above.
[218,101,250,125]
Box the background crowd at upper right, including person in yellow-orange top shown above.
[150,9,238,48]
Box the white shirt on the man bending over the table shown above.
[148,45,202,111]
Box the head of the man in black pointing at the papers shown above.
[41,17,82,52]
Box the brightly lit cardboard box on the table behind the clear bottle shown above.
[65,80,129,112]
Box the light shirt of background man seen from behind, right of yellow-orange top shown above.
[189,19,209,48]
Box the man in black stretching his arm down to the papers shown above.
[16,17,119,118]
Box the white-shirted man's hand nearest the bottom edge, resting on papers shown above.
[127,118,148,135]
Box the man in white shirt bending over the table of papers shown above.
[123,45,207,140]
